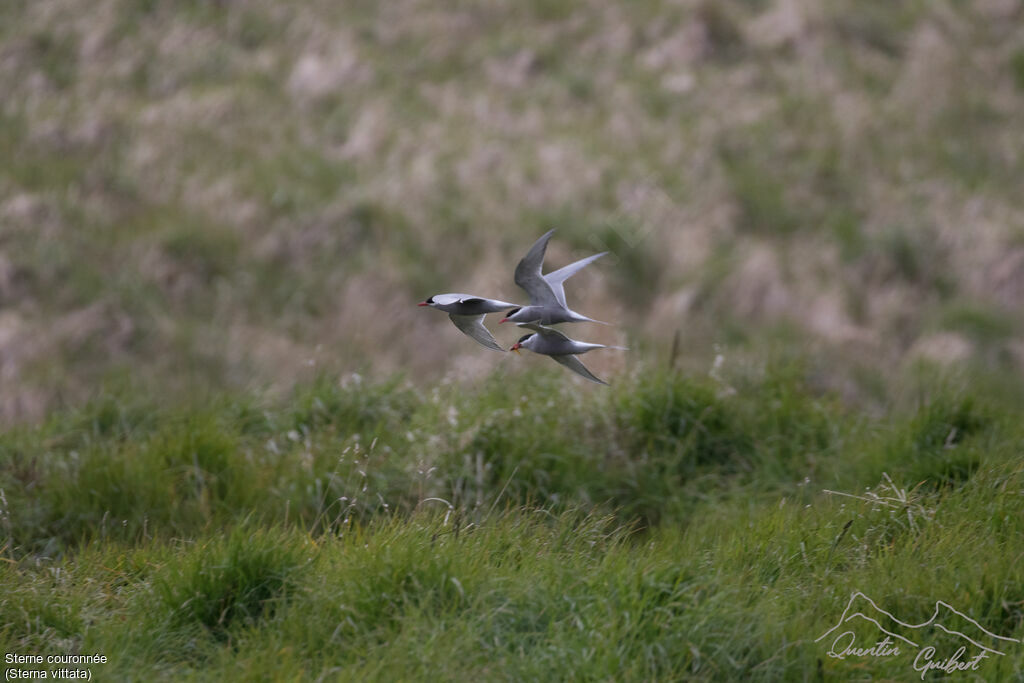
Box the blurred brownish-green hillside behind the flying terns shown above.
[0,0,1024,422]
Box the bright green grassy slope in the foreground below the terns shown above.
[0,365,1024,680]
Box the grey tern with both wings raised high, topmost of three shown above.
[501,230,608,325]
